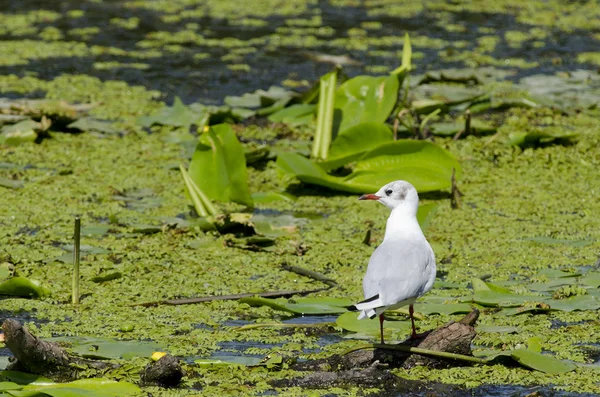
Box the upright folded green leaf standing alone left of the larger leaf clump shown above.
[189,124,254,207]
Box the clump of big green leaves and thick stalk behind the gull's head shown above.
[277,35,460,193]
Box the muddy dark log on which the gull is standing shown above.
[274,310,479,391]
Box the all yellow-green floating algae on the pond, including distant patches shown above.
[0,1,600,396]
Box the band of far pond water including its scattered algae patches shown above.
[0,0,600,104]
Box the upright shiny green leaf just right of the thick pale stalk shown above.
[335,74,400,132]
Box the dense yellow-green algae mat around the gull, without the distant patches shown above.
[0,70,600,395]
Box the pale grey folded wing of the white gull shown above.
[363,239,435,306]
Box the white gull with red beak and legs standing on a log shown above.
[346,181,436,343]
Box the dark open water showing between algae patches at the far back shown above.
[0,0,600,104]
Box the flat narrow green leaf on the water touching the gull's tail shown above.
[239,297,353,315]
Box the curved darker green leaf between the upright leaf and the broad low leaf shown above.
[319,122,393,170]
